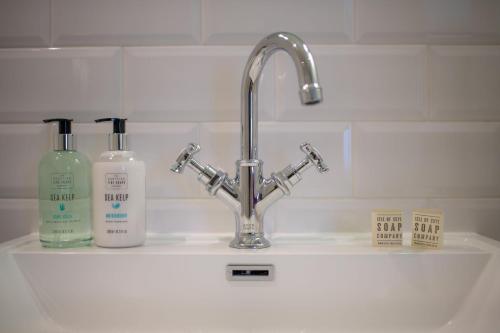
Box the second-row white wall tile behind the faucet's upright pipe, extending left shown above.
[125,46,274,121]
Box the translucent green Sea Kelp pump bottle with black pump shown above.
[38,118,92,248]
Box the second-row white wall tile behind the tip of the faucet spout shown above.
[276,46,427,121]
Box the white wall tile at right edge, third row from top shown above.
[353,122,500,198]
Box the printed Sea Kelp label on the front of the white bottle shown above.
[104,173,129,234]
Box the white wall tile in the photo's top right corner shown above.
[355,0,500,44]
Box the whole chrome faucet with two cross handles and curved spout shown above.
[170,32,328,249]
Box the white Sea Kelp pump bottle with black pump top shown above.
[92,118,146,247]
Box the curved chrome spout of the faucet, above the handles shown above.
[241,32,323,160]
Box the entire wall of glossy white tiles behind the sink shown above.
[0,0,500,241]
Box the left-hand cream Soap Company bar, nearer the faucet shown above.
[372,209,403,246]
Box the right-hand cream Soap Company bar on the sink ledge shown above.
[411,209,443,249]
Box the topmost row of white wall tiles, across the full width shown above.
[0,0,500,47]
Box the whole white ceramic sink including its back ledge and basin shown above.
[0,233,500,333]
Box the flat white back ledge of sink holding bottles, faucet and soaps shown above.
[4,232,500,255]
